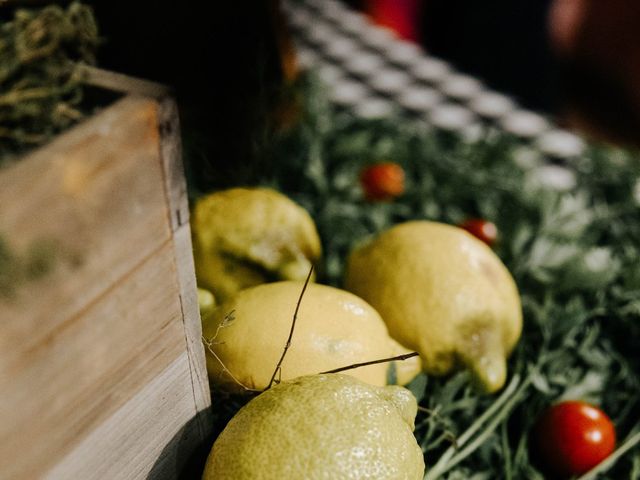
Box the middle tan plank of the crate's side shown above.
[0,242,185,479]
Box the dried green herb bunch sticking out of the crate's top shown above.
[0,2,99,166]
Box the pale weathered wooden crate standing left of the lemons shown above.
[0,84,211,479]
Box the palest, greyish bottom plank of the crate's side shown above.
[47,353,201,480]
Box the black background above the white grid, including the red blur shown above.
[347,0,559,112]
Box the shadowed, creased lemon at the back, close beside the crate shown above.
[191,188,321,301]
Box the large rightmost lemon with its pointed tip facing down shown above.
[345,221,522,392]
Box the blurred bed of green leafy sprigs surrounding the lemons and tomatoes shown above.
[202,77,640,480]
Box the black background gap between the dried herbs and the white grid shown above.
[89,0,282,188]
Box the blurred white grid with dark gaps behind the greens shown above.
[283,0,585,159]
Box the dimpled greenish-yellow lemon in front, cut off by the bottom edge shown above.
[203,374,424,480]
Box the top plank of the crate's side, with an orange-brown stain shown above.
[0,98,171,362]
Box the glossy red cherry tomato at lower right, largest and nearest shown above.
[534,401,616,477]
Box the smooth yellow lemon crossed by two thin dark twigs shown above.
[203,281,417,392]
